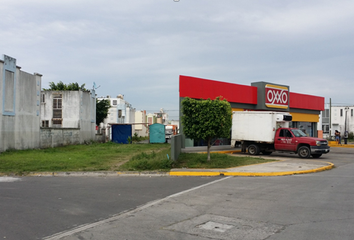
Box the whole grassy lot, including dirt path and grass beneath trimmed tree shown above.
[0,143,276,174]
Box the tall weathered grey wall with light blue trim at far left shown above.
[0,55,42,152]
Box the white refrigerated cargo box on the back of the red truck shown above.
[231,111,292,145]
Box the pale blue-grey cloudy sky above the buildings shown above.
[0,0,354,119]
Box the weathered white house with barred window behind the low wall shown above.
[41,90,96,147]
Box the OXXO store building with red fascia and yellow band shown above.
[179,76,325,147]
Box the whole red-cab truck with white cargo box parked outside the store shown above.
[231,111,330,158]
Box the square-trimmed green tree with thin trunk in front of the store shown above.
[182,96,232,161]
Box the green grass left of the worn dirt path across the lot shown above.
[0,142,171,175]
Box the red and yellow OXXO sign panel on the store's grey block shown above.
[265,84,289,108]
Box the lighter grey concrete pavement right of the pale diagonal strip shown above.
[50,149,354,240]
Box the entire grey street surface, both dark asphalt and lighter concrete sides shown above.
[0,148,354,240]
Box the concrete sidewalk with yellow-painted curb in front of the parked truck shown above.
[170,145,334,176]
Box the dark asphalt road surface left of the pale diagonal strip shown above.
[0,177,220,240]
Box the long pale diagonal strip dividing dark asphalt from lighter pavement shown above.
[43,177,231,240]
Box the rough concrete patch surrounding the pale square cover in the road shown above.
[164,214,284,240]
